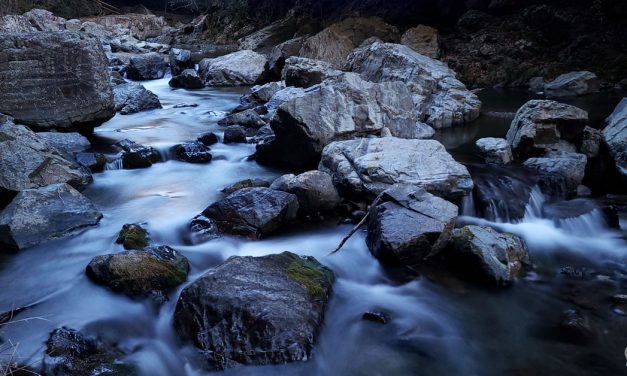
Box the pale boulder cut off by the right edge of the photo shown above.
[603,98,627,182]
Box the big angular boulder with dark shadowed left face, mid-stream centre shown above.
[258,73,418,168]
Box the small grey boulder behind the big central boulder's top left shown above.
[281,57,342,88]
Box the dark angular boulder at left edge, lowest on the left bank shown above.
[0,184,102,251]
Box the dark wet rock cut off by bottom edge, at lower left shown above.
[43,328,139,376]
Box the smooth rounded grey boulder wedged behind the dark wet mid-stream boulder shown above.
[270,170,342,214]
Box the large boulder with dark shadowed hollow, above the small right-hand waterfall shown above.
[507,100,588,159]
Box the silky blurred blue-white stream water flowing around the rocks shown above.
[0,79,627,375]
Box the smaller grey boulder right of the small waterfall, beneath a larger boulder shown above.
[523,151,588,196]
